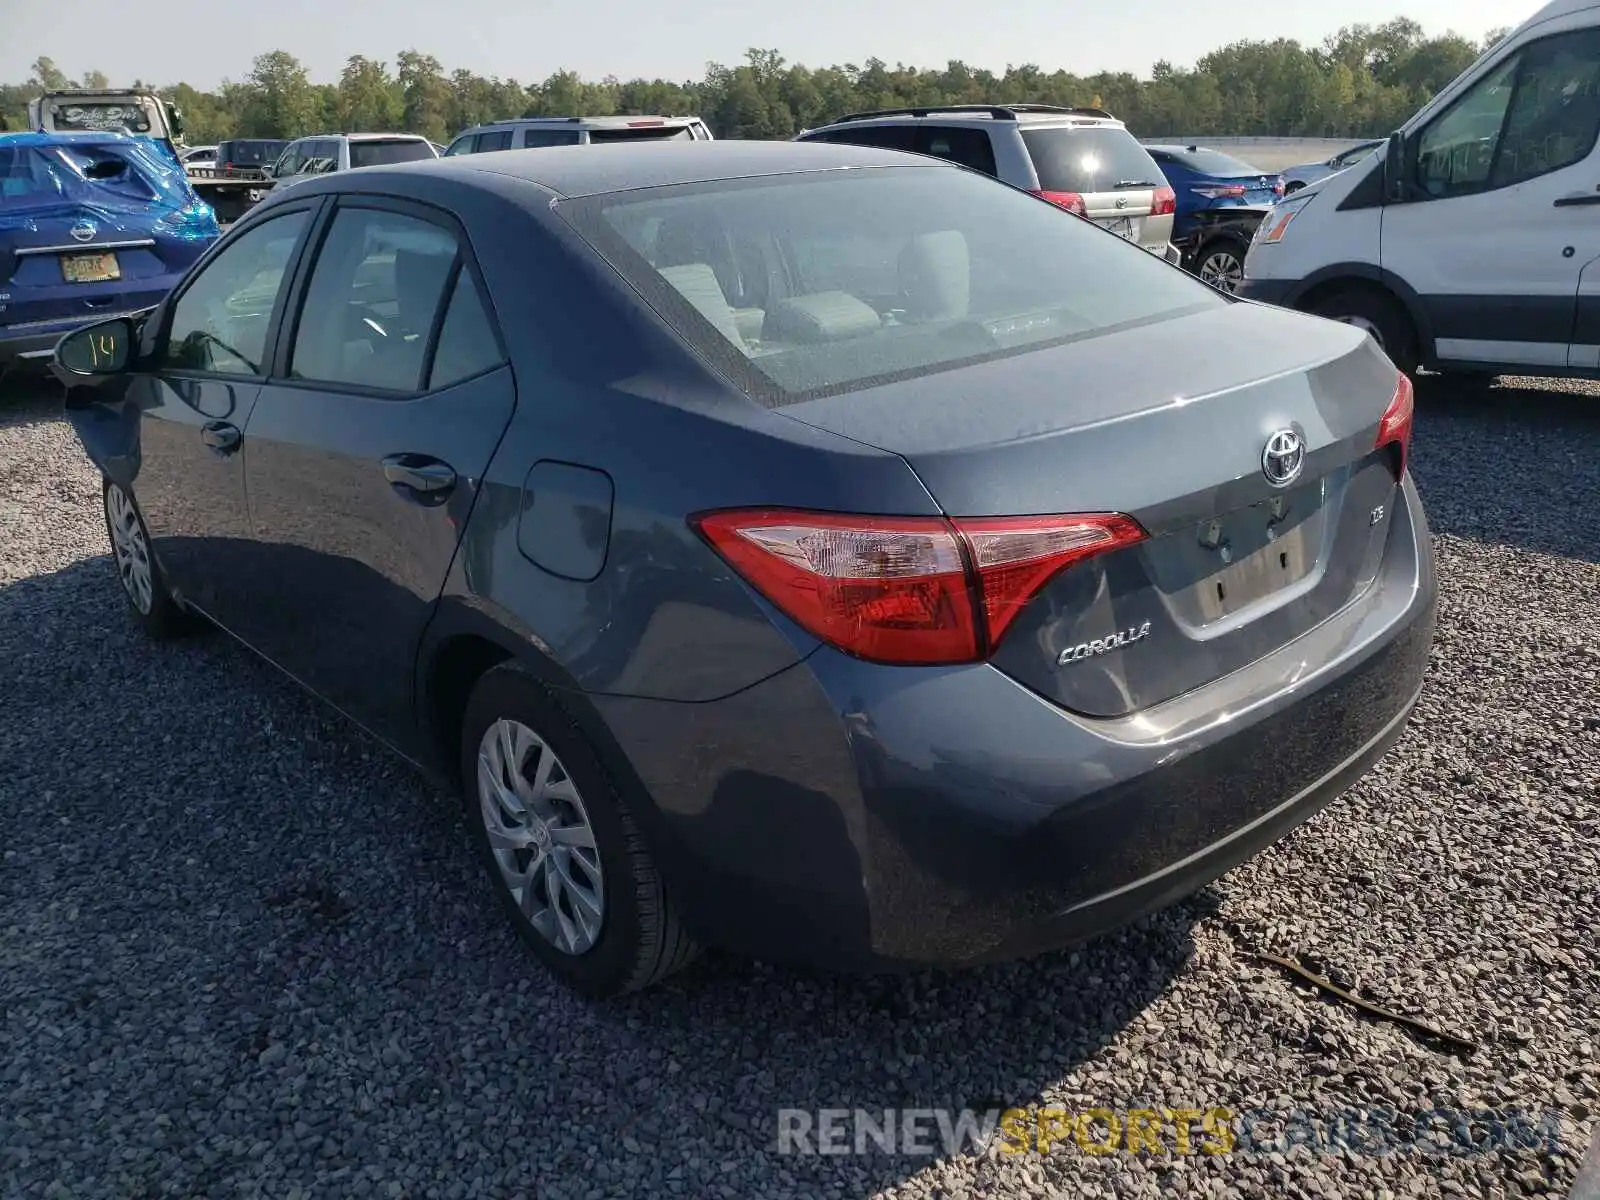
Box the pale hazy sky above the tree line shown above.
[0,0,1541,90]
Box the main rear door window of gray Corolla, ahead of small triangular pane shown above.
[290,208,458,392]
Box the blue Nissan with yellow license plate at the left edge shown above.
[0,133,219,371]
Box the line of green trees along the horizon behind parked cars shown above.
[0,18,1506,146]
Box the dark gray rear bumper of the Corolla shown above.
[595,480,1435,970]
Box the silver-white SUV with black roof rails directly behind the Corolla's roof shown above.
[795,104,1181,264]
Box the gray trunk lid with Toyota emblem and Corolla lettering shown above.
[781,304,1398,717]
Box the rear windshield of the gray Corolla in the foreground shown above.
[558,166,1227,405]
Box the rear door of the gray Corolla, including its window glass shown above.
[237,197,515,744]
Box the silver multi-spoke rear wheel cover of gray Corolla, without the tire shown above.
[478,720,605,955]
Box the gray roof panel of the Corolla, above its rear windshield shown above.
[406,141,957,197]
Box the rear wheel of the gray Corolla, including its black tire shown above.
[461,664,696,998]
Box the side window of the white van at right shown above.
[1416,29,1600,198]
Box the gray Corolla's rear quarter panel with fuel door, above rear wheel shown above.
[427,179,938,701]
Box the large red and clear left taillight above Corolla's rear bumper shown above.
[690,509,1146,666]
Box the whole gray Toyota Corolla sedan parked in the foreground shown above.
[56,142,1435,995]
